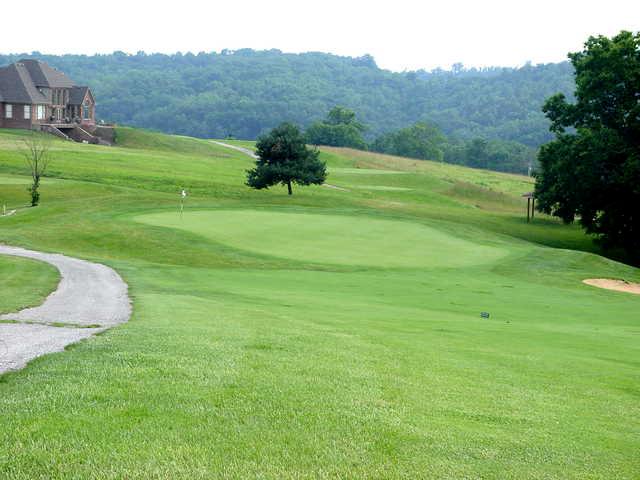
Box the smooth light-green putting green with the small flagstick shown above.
[136,210,506,267]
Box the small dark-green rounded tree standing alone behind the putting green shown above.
[247,123,327,195]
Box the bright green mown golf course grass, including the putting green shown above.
[0,129,640,479]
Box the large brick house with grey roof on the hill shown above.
[0,60,110,143]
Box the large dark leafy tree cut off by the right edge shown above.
[535,32,640,255]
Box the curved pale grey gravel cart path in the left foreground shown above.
[0,245,131,373]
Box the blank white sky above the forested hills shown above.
[0,0,640,71]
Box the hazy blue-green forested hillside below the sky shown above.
[0,49,574,147]
